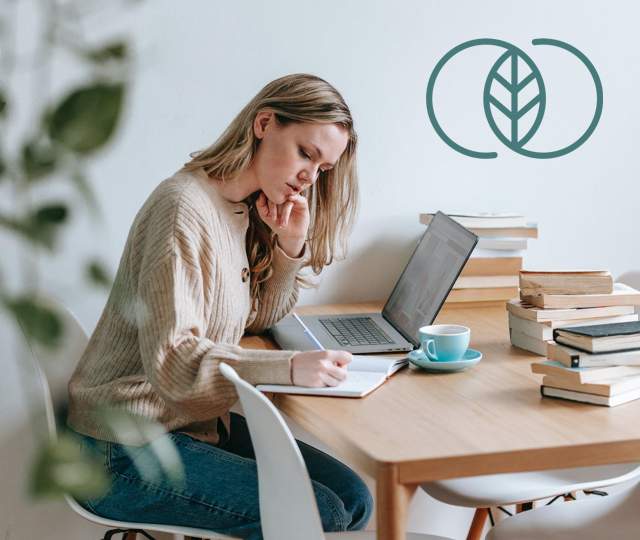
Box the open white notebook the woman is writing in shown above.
[256,354,408,397]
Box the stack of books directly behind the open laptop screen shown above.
[420,213,538,303]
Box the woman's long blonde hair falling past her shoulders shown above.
[185,74,358,308]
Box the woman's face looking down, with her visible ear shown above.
[251,111,349,204]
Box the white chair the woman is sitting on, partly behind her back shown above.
[23,297,231,540]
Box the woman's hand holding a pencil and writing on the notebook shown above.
[291,351,351,387]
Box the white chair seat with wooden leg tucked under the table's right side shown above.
[422,463,640,540]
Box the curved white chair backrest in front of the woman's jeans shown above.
[220,363,324,540]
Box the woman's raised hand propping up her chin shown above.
[256,192,310,258]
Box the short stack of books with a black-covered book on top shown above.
[531,321,640,407]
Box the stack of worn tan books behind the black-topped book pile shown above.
[507,270,640,356]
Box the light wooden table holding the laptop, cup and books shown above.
[244,304,640,540]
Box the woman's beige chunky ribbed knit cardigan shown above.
[68,170,303,445]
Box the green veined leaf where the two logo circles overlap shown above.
[483,49,547,150]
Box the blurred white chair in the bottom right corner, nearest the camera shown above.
[486,478,640,540]
